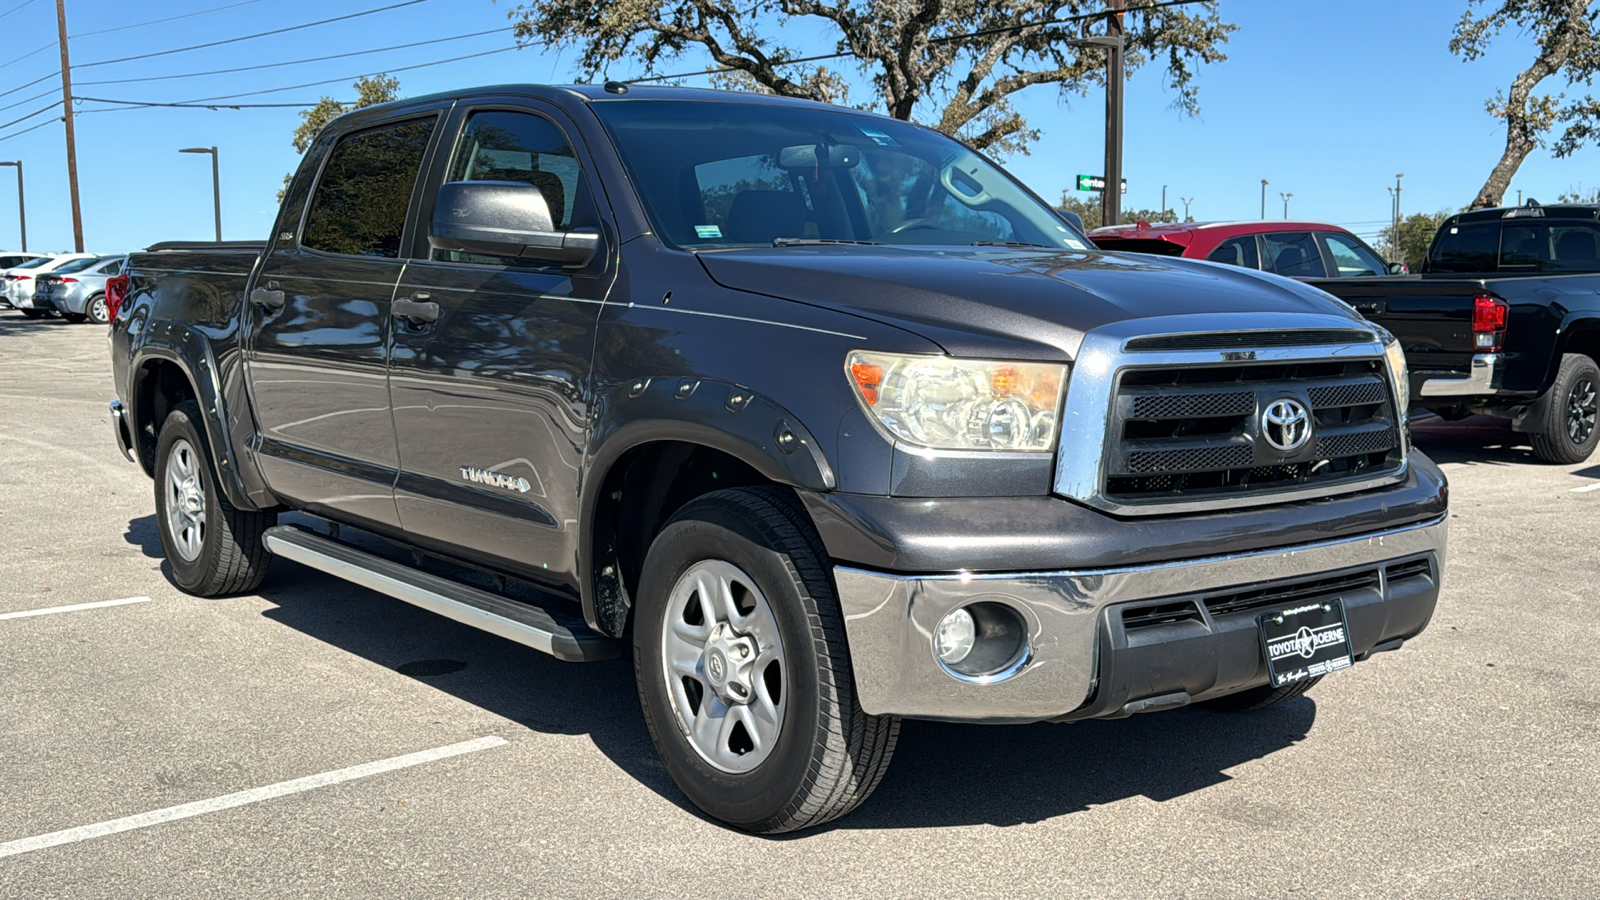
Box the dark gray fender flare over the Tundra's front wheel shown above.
[578,376,838,634]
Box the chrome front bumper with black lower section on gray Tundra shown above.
[834,517,1448,722]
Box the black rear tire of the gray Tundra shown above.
[155,400,278,597]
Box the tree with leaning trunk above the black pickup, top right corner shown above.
[1450,0,1600,208]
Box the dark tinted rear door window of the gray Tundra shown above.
[301,119,434,259]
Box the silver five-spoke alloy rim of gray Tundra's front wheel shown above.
[661,559,789,773]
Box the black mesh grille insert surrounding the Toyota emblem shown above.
[1104,359,1403,503]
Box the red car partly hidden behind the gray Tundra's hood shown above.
[1090,221,1405,279]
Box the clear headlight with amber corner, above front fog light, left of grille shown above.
[845,352,1067,450]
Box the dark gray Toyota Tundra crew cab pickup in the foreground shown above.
[110,85,1446,833]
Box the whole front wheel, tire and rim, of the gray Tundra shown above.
[634,488,899,834]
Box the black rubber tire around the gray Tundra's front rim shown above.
[634,488,899,834]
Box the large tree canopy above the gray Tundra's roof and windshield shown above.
[510,0,1237,154]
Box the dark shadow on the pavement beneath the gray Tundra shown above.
[126,516,1317,839]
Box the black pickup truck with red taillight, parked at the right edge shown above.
[1309,203,1600,464]
